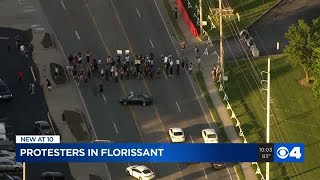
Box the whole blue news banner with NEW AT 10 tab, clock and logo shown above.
[16,136,304,163]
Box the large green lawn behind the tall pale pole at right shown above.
[225,56,320,180]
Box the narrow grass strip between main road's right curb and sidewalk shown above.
[195,71,229,142]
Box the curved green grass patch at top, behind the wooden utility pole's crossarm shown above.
[183,0,278,39]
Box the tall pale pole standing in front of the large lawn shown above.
[261,58,271,180]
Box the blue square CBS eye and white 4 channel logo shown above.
[274,143,304,162]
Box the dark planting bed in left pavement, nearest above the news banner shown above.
[62,110,90,142]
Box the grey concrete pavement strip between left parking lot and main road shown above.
[32,32,107,180]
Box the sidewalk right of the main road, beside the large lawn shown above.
[169,0,258,180]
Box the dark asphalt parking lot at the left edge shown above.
[0,28,72,180]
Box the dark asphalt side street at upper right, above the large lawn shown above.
[213,0,320,60]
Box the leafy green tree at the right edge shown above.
[284,18,320,83]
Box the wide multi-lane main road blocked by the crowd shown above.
[40,0,235,179]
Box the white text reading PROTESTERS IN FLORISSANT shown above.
[20,148,164,157]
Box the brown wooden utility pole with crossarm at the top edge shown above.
[215,0,233,86]
